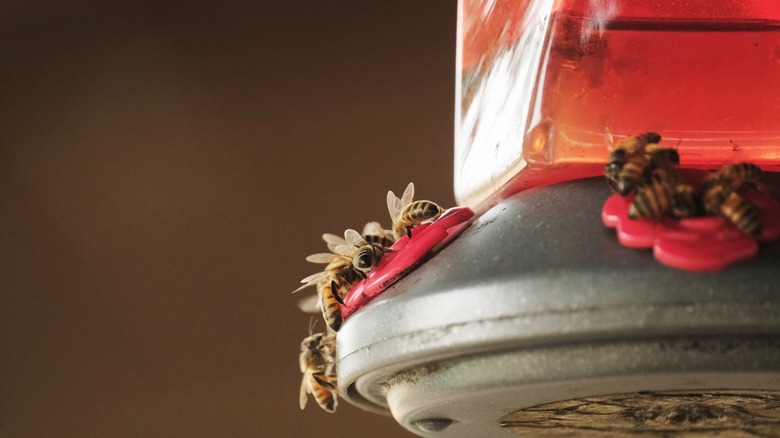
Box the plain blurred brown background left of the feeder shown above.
[0,0,456,438]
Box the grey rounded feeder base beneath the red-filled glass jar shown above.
[337,174,780,437]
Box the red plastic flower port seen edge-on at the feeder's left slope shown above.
[341,207,474,319]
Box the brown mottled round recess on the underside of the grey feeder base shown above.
[500,390,780,437]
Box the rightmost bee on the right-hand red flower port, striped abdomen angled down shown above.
[699,163,761,236]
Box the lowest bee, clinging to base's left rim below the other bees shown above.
[298,333,338,413]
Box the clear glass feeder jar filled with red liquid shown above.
[455,0,780,208]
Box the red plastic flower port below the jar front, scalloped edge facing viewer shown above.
[601,184,780,272]
